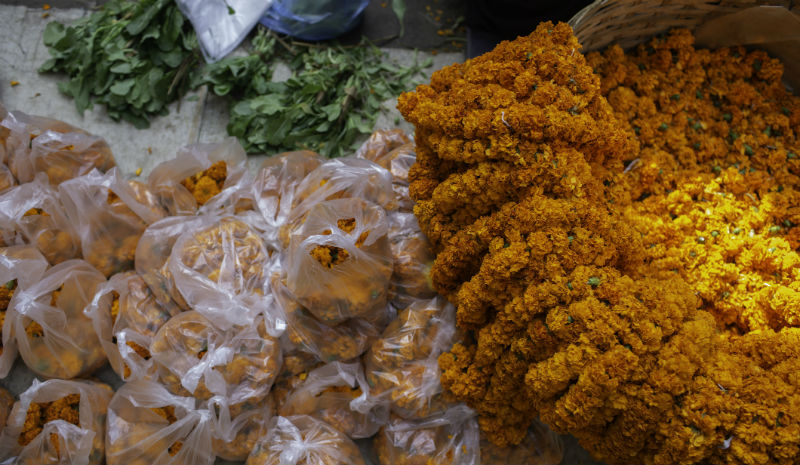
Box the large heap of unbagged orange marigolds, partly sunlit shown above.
[398,23,800,465]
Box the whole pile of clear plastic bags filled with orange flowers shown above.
[0,101,562,465]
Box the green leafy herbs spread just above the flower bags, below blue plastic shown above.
[205,30,430,157]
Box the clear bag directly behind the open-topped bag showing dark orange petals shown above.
[289,157,397,228]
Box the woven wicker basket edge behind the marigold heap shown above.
[569,0,800,53]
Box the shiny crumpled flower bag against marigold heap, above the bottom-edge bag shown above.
[364,297,455,418]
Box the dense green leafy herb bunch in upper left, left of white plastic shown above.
[39,0,199,128]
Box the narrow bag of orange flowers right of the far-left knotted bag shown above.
[85,271,177,381]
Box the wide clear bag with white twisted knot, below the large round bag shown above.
[150,311,281,410]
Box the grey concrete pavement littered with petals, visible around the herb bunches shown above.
[0,0,598,465]
